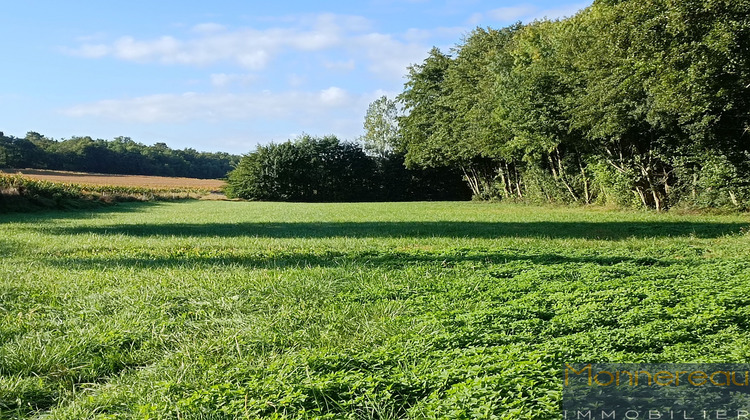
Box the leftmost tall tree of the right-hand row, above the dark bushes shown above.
[398,27,517,196]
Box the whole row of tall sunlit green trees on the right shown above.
[394,0,750,210]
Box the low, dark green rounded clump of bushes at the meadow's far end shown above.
[226,135,471,202]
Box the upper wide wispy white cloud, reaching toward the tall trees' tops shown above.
[64,14,440,81]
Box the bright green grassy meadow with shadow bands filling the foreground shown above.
[0,201,750,419]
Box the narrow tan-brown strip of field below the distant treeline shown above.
[0,169,225,191]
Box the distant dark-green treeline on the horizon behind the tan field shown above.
[0,132,240,179]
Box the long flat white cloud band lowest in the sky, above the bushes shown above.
[62,86,361,123]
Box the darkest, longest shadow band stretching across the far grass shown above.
[44,221,747,240]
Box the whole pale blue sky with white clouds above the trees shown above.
[0,0,591,154]
